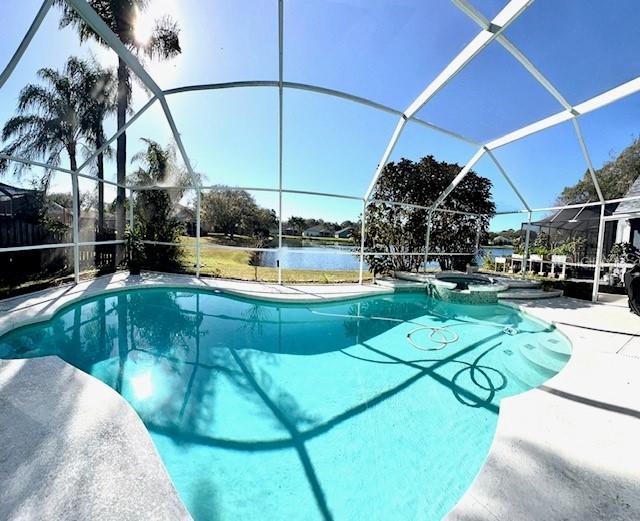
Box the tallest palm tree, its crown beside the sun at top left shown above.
[56,0,182,245]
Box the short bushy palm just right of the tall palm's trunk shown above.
[131,138,192,270]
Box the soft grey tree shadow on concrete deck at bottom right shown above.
[446,439,640,521]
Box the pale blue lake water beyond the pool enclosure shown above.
[262,244,512,271]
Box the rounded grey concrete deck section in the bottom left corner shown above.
[0,356,192,521]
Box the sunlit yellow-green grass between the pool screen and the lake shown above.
[180,236,373,283]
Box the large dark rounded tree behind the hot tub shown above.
[365,156,495,274]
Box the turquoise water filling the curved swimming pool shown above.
[0,288,569,521]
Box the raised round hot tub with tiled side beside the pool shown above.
[427,271,508,304]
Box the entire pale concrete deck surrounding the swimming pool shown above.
[0,273,640,521]
